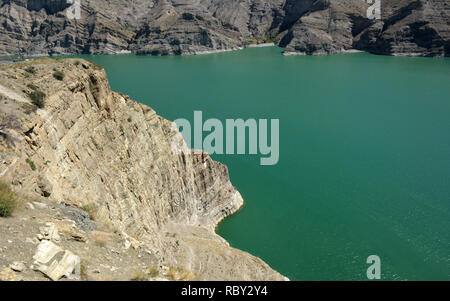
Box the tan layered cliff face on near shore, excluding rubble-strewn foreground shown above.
[0,59,284,280]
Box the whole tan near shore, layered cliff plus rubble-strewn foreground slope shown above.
[0,59,286,280]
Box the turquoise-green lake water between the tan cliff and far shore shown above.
[78,47,450,280]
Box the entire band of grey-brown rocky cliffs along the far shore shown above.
[0,0,450,56]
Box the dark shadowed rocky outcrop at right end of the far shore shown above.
[354,0,450,56]
